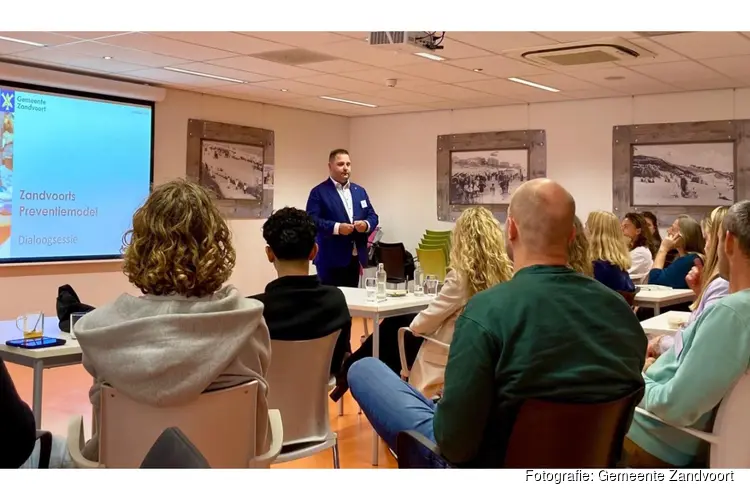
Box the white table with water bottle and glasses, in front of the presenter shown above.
[339,287,435,466]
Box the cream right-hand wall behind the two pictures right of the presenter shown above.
[349,89,750,252]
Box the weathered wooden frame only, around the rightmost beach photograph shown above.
[612,120,750,227]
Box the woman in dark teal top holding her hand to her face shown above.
[648,215,706,288]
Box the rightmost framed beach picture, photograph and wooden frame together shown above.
[612,120,750,227]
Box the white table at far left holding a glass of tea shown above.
[0,317,82,429]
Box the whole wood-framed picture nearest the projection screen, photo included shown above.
[186,119,275,219]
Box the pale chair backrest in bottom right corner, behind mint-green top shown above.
[710,372,750,469]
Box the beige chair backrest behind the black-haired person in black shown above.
[267,330,341,446]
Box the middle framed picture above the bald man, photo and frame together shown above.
[437,130,547,222]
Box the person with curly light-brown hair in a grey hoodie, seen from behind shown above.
[76,180,271,460]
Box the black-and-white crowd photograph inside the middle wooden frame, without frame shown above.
[450,149,529,205]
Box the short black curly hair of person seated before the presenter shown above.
[263,207,317,261]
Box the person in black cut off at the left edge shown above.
[0,359,36,469]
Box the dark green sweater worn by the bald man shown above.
[433,266,647,467]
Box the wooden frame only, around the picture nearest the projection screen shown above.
[187,119,275,219]
